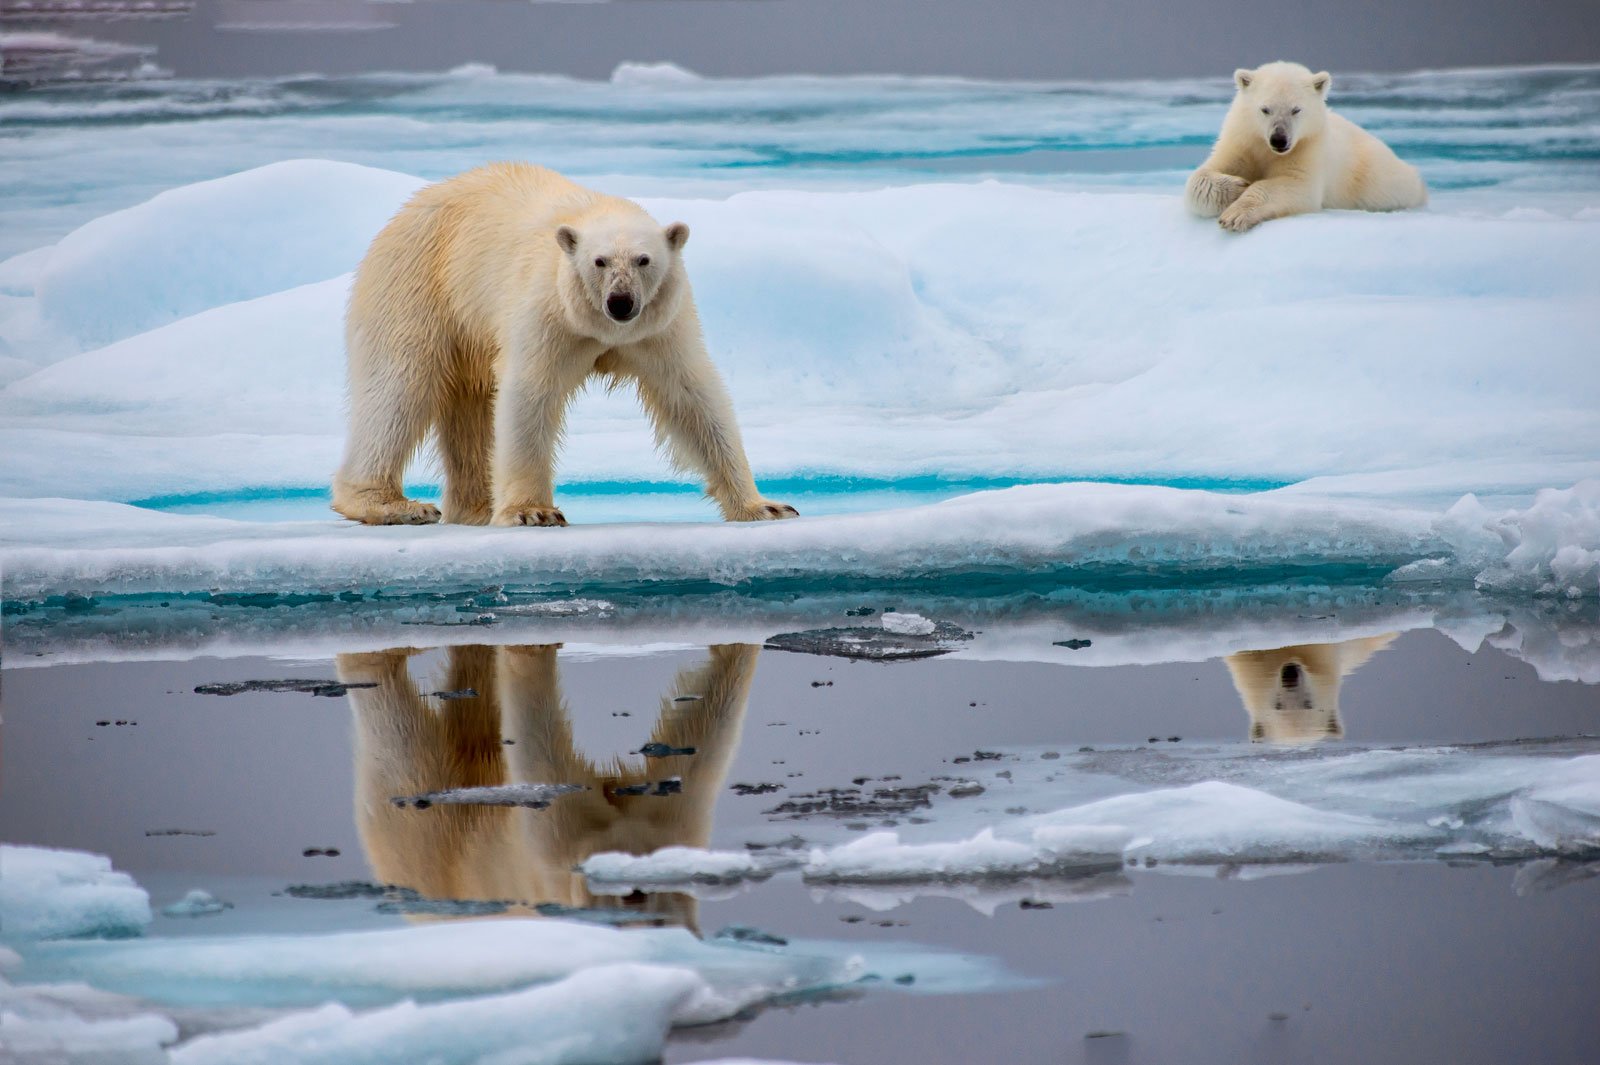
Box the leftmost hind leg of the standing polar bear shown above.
[333,326,438,525]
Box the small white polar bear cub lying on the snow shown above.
[1186,62,1427,233]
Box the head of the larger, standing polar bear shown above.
[555,213,690,326]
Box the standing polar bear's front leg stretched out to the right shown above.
[619,323,800,521]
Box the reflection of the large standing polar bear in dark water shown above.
[338,644,760,927]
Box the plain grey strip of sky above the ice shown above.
[62,0,1600,78]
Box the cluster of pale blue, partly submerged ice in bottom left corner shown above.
[0,848,1011,1065]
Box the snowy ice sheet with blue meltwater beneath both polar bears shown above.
[0,64,1600,598]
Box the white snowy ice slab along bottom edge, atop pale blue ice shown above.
[171,964,710,1065]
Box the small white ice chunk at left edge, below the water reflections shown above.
[0,846,150,940]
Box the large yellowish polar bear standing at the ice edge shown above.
[333,163,795,525]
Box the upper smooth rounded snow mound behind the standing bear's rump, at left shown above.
[35,160,424,347]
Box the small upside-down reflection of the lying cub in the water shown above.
[1227,632,1397,744]
